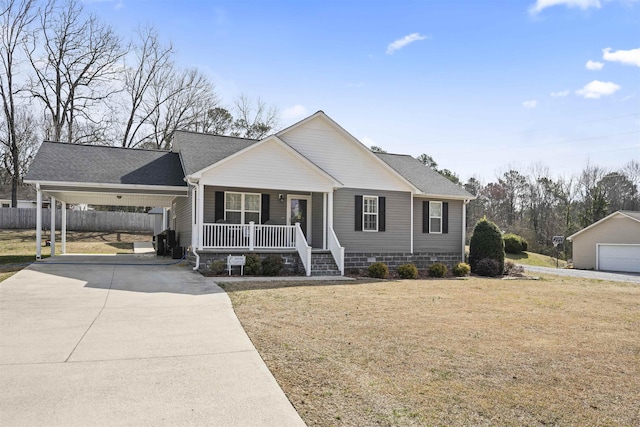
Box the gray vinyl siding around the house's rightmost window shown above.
[413,197,462,253]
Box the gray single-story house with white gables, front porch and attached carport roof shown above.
[25,111,474,275]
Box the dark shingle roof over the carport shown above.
[25,141,187,186]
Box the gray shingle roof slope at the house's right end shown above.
[375,153,475,199]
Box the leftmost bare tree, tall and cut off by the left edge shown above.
[0,0,35,207]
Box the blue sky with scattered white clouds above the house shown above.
[86,0,640,181]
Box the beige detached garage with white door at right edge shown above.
[567,211,640,273]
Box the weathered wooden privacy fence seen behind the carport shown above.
[0,208,154,232]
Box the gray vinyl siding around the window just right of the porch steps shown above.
[333,188,411,252]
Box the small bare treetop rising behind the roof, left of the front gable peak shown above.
[231,95,278,139]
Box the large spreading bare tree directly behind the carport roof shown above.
[29,0,125,142]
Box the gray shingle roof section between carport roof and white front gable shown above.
[173,131,258,175]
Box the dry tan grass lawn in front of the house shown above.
[224,276,640,426]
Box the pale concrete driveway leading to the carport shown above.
[0,255,304,426]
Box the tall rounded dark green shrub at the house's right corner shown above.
[469,218,504,275]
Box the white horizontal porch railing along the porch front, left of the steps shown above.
[202,222,298,251]
